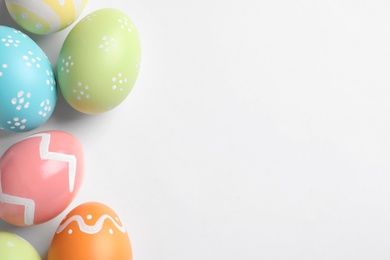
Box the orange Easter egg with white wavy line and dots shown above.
[48,202,132,260]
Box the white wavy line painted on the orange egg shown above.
[56,214,126,235]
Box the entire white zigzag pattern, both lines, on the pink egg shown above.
[0,133,76,225]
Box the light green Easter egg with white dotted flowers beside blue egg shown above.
[57,8,141,114]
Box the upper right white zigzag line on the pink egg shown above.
[29,133,77,192]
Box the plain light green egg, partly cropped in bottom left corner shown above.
[0,232,41,260]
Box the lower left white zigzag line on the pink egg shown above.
[0,171,35,225]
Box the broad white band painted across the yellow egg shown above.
[6,0,61,32]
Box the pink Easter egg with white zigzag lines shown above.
[0,131,84,226]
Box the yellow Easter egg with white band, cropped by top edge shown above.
[5,0,87,34]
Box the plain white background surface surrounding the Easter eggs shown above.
[0,0,390,260]
